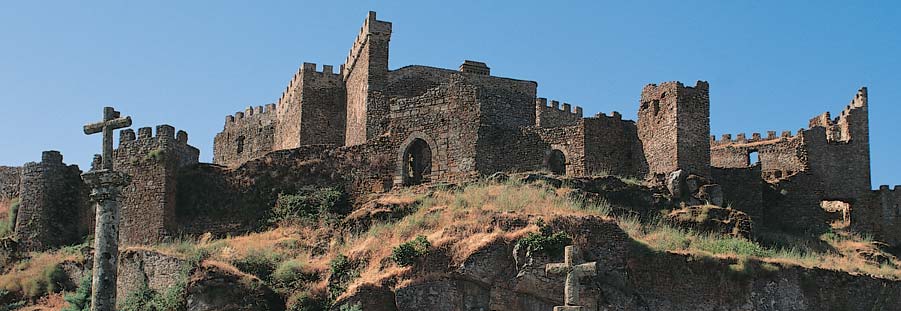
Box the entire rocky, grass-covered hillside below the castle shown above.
[0,174,901,311]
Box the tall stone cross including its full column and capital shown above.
[81,107,131,311]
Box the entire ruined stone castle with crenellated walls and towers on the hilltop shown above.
[0,12,901,254]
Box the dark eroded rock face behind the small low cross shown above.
[348,217,901,311]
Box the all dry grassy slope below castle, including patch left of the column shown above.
[7,178,901,305]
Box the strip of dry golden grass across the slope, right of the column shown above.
[134,178,901,304]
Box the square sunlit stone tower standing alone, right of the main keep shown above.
[638,81,710,176]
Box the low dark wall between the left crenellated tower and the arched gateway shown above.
[176,143,395,236]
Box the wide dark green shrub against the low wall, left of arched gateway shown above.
[270,187,348,223]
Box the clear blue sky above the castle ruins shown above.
[0,1,901,186]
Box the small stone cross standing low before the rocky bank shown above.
[544,245,597,311]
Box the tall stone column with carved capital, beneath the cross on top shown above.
[82,170,131,311]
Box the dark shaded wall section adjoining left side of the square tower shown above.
[584,111,646,177]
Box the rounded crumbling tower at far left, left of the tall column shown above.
[15,151,93,251]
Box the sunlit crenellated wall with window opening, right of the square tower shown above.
[710,131,809,181]
